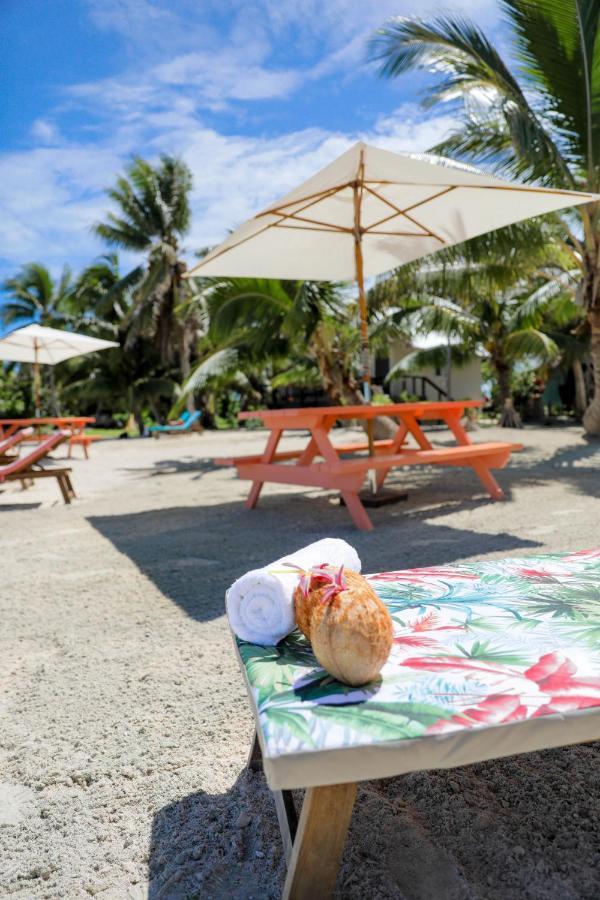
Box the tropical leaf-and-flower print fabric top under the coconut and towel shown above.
[237,550,600,758]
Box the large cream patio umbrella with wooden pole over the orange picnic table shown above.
[187,142,600,412]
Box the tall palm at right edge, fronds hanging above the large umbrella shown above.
[371,0,600,434]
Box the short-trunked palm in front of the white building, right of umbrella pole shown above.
[374,222,573,427]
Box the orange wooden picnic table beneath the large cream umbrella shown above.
[217,400,522,530]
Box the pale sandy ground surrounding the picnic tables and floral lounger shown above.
[0,428,600,900]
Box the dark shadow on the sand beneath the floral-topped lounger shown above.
[148,744,600,900]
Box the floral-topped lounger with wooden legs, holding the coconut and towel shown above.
[234,550,600,900]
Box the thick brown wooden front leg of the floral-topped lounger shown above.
[283,782,356,900]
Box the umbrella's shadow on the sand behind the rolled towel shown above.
[88,494,539,621]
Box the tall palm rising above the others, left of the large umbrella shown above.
[95,155,192,362]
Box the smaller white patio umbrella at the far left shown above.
[0,325,119,416]
